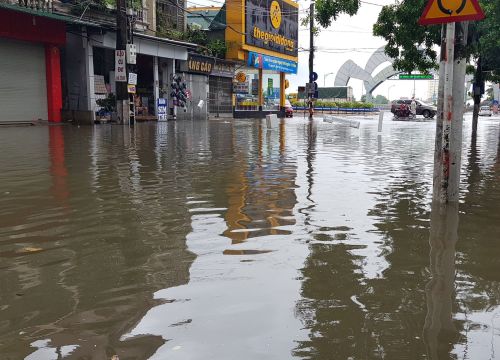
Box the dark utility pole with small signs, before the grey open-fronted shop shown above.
[115,0,130,124]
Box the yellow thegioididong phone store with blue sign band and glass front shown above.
[225,0,298,118]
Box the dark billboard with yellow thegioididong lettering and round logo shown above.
[245,0,299,56]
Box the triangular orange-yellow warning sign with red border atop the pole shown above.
[418,0,484,25]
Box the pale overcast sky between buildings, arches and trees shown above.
[188,0,436,100]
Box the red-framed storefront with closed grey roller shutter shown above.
[0,5,66,123]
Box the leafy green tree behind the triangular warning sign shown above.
[373,0,500,134]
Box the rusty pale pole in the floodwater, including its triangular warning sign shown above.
[419,0,484,204]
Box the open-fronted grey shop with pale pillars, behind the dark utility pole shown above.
[65,28,197,122]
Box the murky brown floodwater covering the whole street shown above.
[0,117,500,360]
